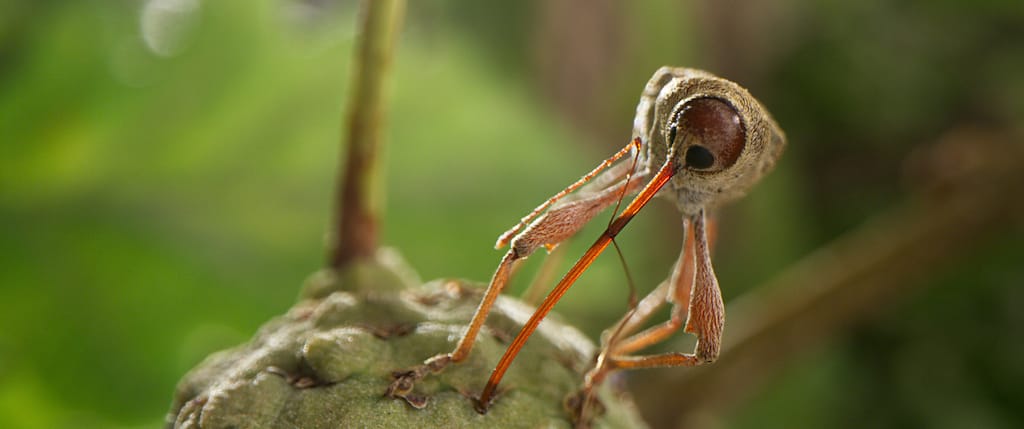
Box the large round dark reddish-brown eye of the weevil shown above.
[676,97,746,172]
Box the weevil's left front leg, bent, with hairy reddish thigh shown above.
[387,138,641,406]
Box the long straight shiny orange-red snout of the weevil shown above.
[476,151,678,413]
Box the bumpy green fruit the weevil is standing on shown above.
[167,249,644,428]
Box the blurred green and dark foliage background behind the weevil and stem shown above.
[0,0,1024,428]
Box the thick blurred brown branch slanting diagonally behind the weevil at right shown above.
[636,126,1024,427]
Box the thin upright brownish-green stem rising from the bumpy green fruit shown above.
[328,0,406,269]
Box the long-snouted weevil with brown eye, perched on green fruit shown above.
[387,67,785,413]
